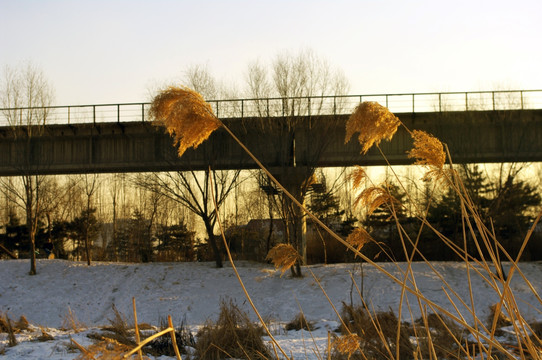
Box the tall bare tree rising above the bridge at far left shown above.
[0,64,53,275]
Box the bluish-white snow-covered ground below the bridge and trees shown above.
[0,260,542,359]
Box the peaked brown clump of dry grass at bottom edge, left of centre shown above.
[195,301,271,360]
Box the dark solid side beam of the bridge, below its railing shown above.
[0,110,542,176]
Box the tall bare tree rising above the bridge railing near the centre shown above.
[243,50,349,276]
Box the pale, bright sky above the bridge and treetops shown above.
[0,0,542,105]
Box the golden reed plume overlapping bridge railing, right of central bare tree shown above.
[345,101,401,154]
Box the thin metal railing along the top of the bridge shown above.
[0,90,542,126]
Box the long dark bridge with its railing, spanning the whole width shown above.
[0,90,542,176]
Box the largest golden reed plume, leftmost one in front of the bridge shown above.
[149,86,222,157]
